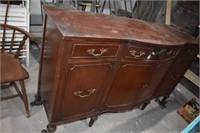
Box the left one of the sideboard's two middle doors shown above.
[106,63,153,107]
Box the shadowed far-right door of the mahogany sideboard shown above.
[155,47,198,97]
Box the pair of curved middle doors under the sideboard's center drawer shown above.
[106,62,171,108]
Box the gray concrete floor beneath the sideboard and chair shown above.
[0,46,195,133]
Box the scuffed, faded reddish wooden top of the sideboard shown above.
[44,6,198,45]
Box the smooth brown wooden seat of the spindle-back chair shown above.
[0,53,29,83]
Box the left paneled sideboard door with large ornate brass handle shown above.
[60,63,112,119]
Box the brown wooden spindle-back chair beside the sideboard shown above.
[0,24,34,117]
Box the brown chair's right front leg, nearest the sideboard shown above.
[19,80,30,118]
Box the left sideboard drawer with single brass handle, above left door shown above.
[71,44,120,58]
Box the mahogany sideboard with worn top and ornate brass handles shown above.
[32,6,198,132]
